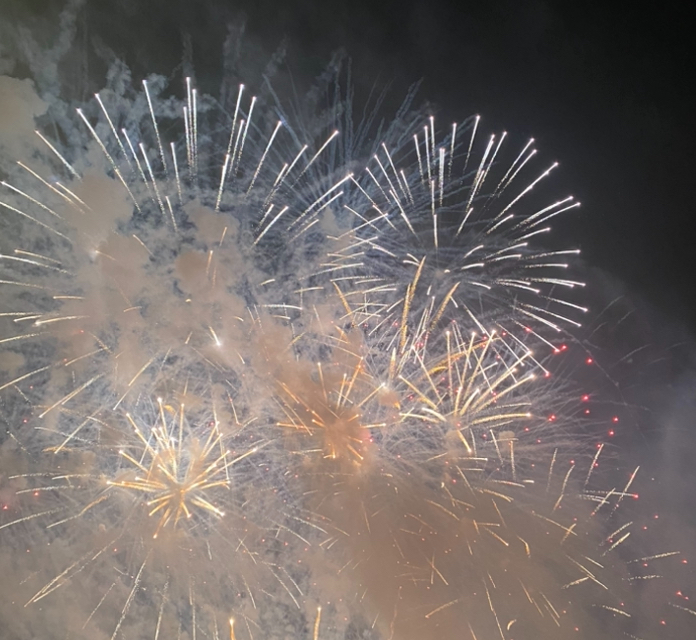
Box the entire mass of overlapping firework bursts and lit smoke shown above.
[0,20,692,640]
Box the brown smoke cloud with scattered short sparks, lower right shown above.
[290,410,664,638]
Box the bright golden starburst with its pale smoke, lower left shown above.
[2,400,282,637]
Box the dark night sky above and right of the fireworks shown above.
[6,0,696,332]
